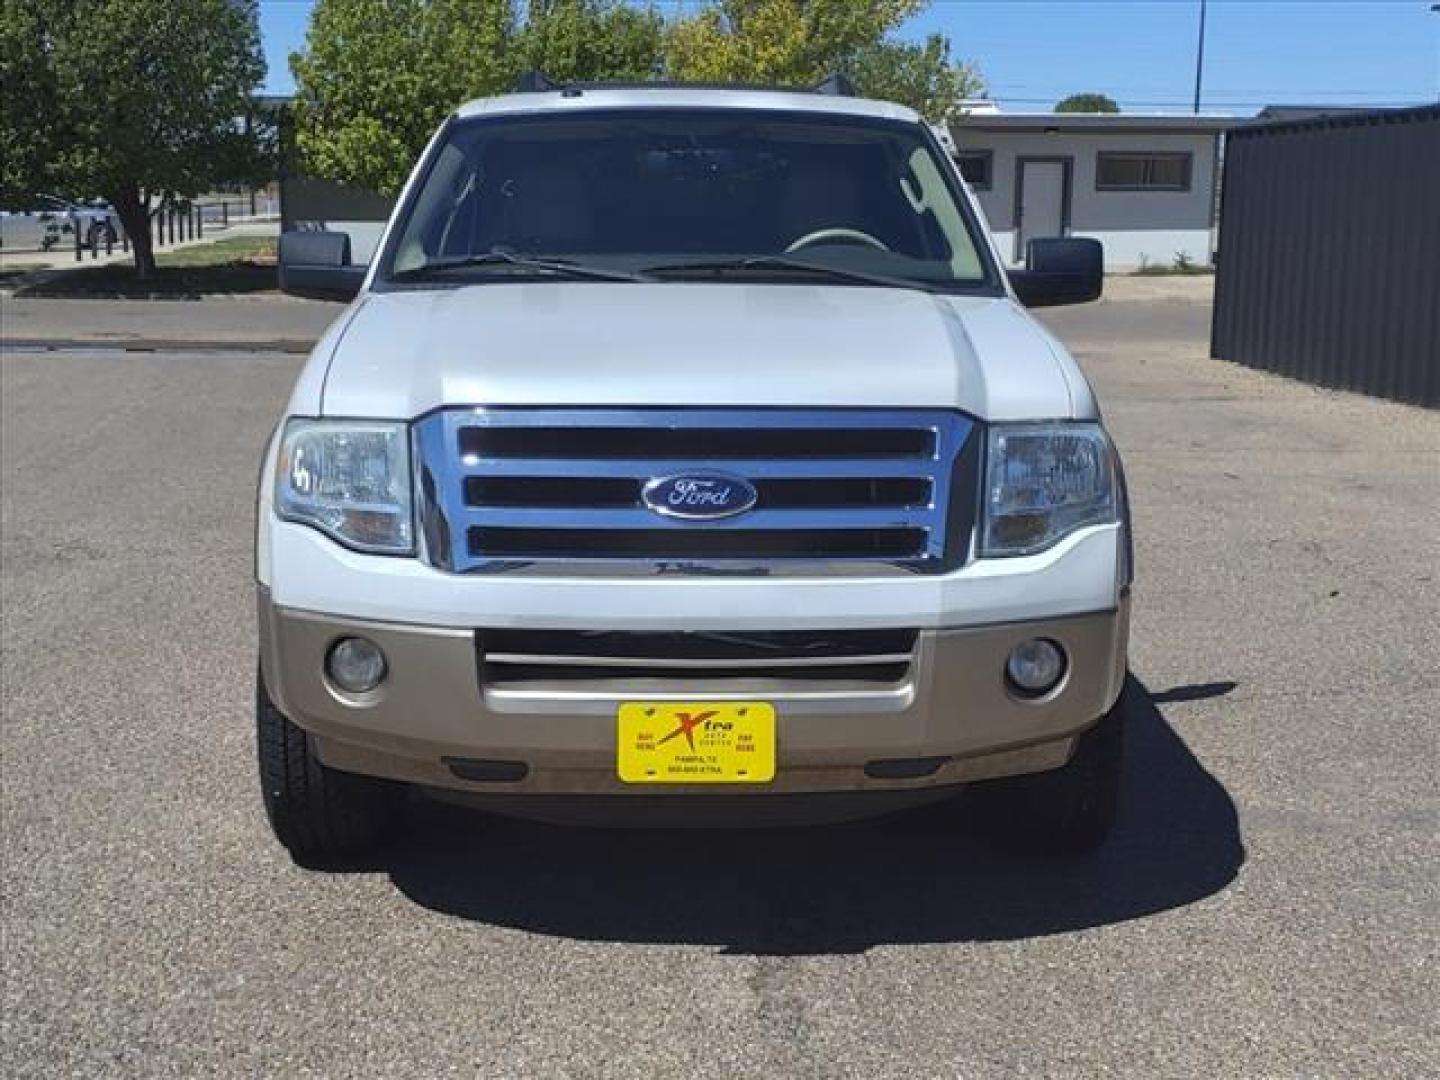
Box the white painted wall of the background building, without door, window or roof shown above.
[953,124,1215,269]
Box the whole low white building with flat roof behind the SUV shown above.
[950,109,1237,269]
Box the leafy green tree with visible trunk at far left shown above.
[0,0,268,278]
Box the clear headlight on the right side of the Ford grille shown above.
[981,423,1119,557]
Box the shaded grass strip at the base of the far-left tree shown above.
[14,236,276,300]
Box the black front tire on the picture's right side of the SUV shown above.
[972,685,1130,855]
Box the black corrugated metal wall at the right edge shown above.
[1210,105,1440,406]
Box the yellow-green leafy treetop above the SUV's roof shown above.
[667,0,926,86]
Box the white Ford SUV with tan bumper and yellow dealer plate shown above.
[256,82,1130,858]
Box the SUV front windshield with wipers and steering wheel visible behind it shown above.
[379,108,994,291]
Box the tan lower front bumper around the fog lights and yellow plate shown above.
[259,590,1129,795]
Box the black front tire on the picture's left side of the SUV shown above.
[255,677,399,864]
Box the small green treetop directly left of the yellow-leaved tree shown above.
[518,0,665,82]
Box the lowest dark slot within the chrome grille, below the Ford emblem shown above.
[468,526,929,559]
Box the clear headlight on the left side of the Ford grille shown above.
[275,419,415,554]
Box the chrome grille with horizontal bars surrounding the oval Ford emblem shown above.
[415,408,979,572]
